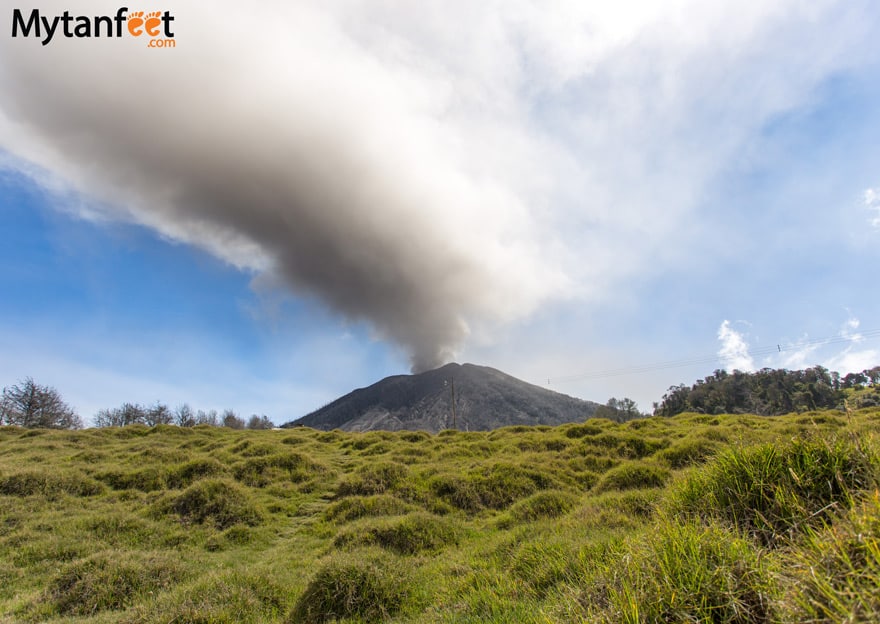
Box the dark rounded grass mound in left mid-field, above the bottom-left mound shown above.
[161,479,263,530]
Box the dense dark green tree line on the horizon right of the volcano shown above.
[654,366,880,416]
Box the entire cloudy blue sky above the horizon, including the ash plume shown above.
[0,0,880,423]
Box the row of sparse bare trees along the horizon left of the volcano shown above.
[0,377,275,429]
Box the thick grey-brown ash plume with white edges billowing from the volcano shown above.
[0,2,565,370]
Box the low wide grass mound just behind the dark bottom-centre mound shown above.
[333,512,460,555]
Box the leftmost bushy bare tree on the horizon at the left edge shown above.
[0,377,82,429]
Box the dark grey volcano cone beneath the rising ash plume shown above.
[283,364,599,433]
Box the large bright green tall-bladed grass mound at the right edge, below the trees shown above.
[669,437,878,544]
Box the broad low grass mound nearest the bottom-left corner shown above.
[42,551,183,615]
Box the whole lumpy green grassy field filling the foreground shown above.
[0,409,880,624]
